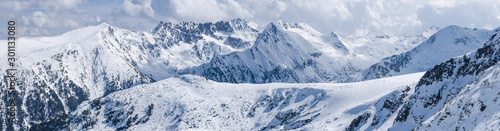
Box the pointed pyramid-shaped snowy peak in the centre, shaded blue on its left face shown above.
[183,21,367,83]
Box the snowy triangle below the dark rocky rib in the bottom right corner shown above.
[417,63,500,131]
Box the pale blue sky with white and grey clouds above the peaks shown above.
[0,0,500,39]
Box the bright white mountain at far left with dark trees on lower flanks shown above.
[0,24,152,130]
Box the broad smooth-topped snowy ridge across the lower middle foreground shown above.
[69,73,423,130]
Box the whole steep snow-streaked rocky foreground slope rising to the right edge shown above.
[330,31,500,130]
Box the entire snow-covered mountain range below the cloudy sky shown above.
[0,19,500,130]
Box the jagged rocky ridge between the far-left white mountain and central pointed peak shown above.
[133,19,258,80]
